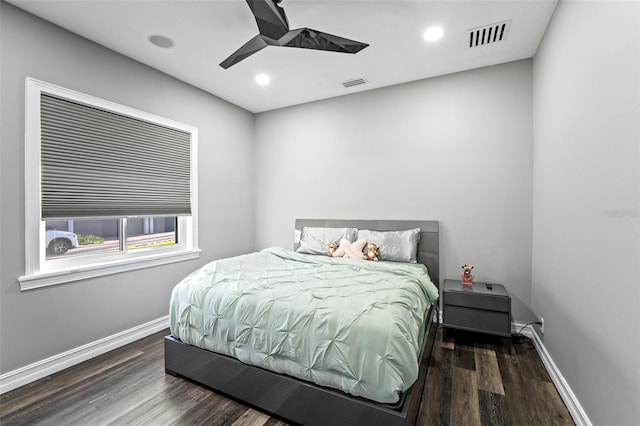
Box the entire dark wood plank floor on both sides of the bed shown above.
[0,330,573,426]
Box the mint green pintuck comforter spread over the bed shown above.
[170,248,438,403]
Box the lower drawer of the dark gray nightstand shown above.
[442,305,511,336]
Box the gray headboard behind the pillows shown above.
[294,219,440,287]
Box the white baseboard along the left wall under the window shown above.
[0,315,169,394]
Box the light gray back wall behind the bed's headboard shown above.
[255,60,533,318]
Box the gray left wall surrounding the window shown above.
[0,3,254,373]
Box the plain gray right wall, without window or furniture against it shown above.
[532,1,640,425]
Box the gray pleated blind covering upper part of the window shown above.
[40,93,191,219]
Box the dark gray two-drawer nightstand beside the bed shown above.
[442,280,511,338]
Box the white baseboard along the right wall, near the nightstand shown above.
[513,323,593,426]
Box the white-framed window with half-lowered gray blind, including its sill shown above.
[20,78,199,290]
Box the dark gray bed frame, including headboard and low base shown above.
[165,219,440,426]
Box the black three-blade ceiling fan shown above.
[220,0,369,69]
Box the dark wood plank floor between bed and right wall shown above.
[418,330,574,426]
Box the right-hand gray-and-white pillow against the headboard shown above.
[358,228,420,263]
